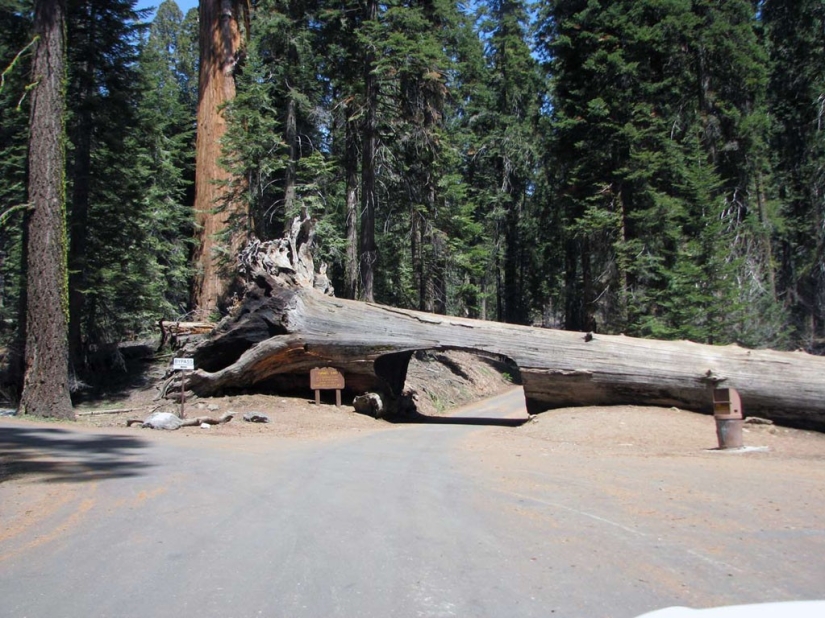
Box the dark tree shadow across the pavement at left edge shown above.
[0,425,149,483]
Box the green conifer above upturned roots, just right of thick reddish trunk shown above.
[223,0,332,241]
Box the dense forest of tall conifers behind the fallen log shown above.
[0,0,825,412]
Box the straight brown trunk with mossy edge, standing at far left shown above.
[20,0,74,418]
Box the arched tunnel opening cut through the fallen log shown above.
[375,347,529,426]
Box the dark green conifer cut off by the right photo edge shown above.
[762,0,825,353]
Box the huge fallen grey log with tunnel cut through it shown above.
[187,288,825,430]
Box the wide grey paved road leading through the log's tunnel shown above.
[0,392,825,618]
